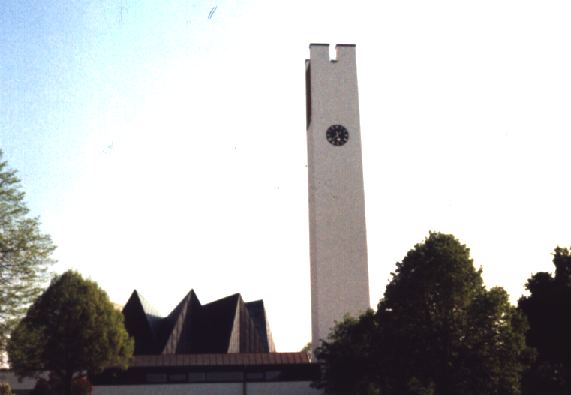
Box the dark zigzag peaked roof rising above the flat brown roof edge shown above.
[123,290,275,355]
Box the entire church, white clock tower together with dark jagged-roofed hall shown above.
[0,44,376,395]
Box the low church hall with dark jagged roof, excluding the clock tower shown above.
[94,290,319,395]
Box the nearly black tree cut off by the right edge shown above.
[518,247,571,395]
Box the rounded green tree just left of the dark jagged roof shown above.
[8,271,133,394]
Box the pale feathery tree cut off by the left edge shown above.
[0,151,55,358]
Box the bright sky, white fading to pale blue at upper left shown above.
[0,0,571,351]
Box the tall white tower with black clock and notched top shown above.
[305,44,370,349]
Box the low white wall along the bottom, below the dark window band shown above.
[93,381,321,395]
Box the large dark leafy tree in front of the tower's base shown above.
[318,232,531,395]
